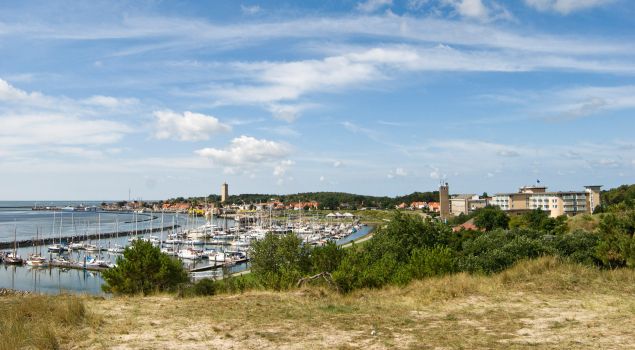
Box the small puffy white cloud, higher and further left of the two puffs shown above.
[154,110,231,141]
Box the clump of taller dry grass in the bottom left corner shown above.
[0,295,99,350]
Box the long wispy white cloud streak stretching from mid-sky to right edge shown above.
[206,45,635,118]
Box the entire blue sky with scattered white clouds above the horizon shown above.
[0,0,635,200]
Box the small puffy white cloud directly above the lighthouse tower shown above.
[195,135,291,167]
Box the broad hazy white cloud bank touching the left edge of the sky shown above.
[0,79,136,159]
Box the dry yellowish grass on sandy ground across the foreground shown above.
[4,258,635,349]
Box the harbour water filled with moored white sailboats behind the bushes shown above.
[0,205,372,295]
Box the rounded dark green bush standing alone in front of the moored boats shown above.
[102,240,189,295]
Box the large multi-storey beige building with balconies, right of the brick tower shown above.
[490,185,602,218]
